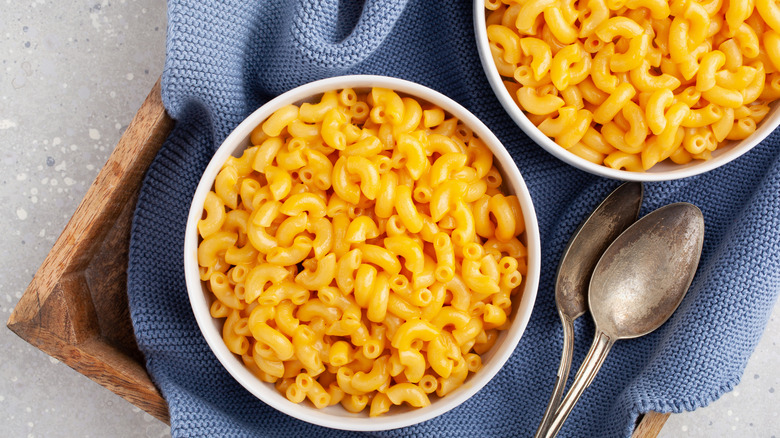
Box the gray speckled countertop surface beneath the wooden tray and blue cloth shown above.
[0,0,780,438]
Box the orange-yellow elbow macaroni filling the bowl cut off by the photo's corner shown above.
[485,0,780,172]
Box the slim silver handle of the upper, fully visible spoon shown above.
[545,330,615,438]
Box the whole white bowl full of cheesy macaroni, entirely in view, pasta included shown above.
[184,76,540,430]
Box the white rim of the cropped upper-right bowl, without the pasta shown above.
[474,0,780,181]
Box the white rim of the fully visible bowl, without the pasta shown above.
[184,76,541,431]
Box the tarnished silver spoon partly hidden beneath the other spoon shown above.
[536,182,644,438]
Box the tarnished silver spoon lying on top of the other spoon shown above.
[545,202,704,438]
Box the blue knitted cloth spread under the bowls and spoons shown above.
[128,0,780,437]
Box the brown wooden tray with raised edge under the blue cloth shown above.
[3,80,669,438]
